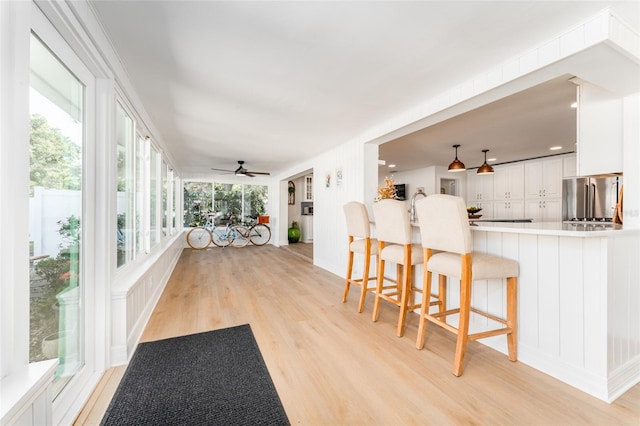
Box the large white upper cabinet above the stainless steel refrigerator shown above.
[572,79,623,176]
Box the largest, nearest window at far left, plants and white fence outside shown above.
[29,34,85,395]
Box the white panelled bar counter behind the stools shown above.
[400,222,640,402]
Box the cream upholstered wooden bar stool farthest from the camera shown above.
[342,201,378,312]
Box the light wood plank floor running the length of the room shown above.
[76,246,640,426]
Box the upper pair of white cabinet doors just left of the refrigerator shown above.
[524,158,563,199]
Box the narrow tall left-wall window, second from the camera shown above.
[116,103,136,267]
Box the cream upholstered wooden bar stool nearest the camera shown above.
[415,194,519,376]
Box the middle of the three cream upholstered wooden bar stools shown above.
[372,199,423,337]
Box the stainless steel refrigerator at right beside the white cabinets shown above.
[562,176,622,222]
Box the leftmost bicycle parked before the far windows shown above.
[187,212,250,250]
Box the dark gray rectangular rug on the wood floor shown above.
[101,324,290,425]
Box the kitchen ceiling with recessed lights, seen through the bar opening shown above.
[380,76,577,175]
